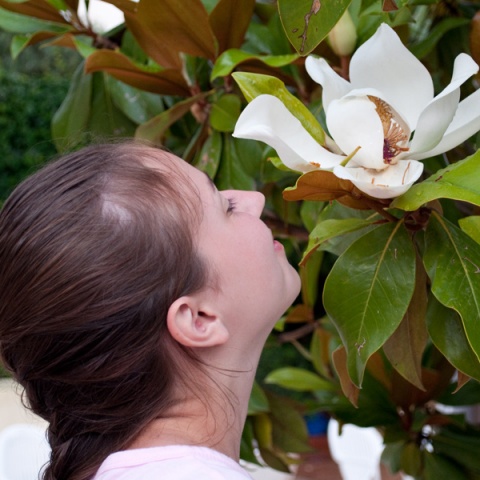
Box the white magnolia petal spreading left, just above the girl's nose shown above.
[233,95,345,172]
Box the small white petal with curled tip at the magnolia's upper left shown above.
[305,56,352,111]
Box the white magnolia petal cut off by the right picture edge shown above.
[409,90,480,160]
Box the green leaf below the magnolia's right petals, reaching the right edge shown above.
[391,151,480,211]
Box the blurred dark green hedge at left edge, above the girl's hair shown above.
[0,32,79,201]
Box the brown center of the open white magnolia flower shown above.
[368,95,409,165]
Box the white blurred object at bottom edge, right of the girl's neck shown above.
[327,418,383,480]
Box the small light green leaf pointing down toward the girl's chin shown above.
[300,217,378,265]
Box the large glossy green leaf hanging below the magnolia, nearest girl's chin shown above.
[323,222,415,387]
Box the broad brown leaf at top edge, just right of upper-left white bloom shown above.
[125,0,217,69]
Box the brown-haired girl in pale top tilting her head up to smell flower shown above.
[0,144,300,480]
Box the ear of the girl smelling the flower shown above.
[167,296,230,347]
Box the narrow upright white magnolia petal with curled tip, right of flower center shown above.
[408,53,478,158]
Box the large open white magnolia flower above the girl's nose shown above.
[233,24,480,198]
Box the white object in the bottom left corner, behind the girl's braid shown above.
[0,423,50,480]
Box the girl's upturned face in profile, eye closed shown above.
[159,153,300,342]
